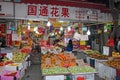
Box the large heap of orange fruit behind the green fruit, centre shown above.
[42,53,76,68]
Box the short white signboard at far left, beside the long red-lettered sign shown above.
[0,2,14,18]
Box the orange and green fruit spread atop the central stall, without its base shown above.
[42,53,96,79]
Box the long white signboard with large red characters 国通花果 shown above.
[15,3,100,21]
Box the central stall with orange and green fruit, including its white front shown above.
[42,49,97,80]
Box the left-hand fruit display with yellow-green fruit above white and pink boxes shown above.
[0,50,29,80]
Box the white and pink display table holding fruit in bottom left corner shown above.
[0,55,30,80]
